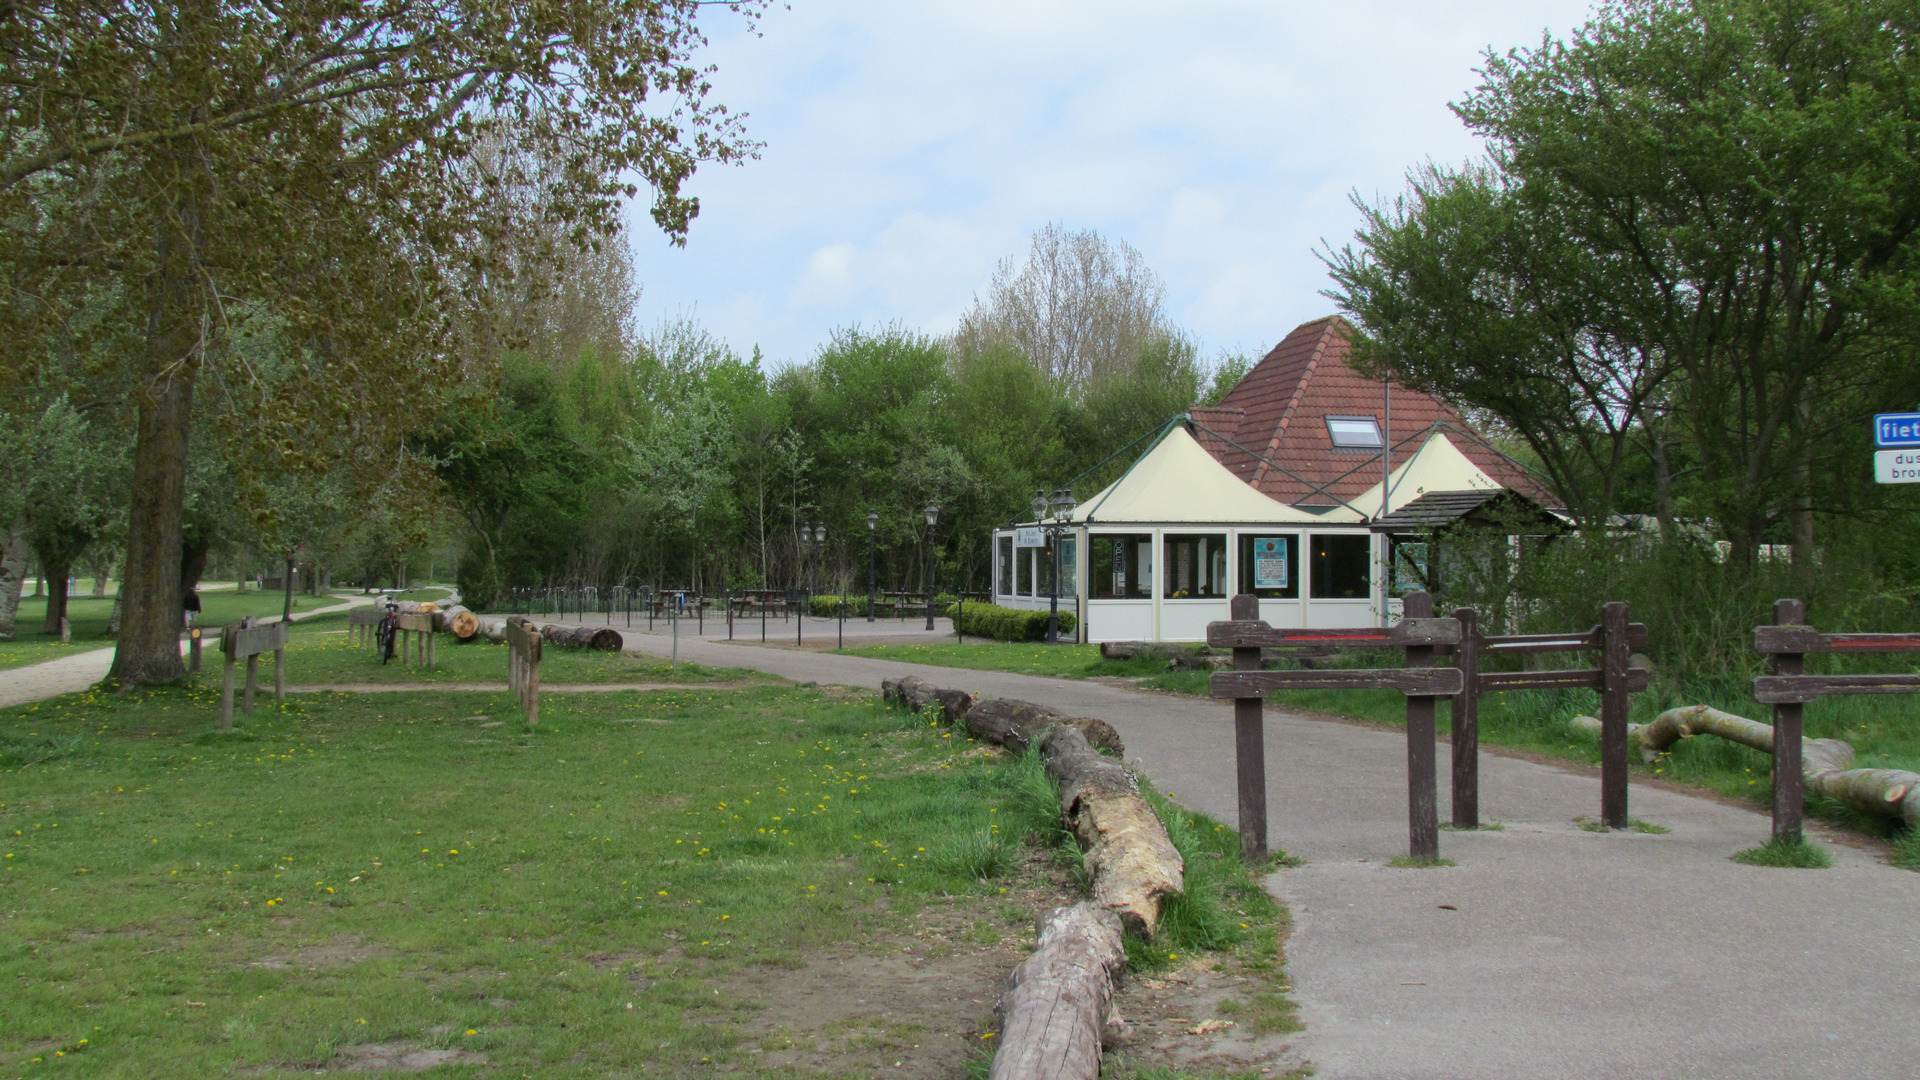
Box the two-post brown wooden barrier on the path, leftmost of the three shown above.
[1206,592,1463,861]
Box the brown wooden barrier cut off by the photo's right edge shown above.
[1753,600,1920,844]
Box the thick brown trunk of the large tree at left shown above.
[108,187,205,690]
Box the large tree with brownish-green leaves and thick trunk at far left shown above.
[0,0,758,686]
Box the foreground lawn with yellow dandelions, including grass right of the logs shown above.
[0,651,1284,1080]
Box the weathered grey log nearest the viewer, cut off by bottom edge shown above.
[987,901,1127,1080]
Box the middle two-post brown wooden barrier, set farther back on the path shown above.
[1452,600,1649,828]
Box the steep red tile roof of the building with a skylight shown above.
[1192,315,1561,513]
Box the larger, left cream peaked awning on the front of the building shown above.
[1073,425,1359,525]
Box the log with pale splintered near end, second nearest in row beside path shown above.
[1041,724,1187,938]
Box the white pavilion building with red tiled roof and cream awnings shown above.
[993,317,1559,642]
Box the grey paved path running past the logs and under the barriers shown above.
[626,628,1920,1080]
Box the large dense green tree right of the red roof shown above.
[1331,0,1920,557]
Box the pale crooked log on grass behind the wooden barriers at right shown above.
[1569,705,1920,826]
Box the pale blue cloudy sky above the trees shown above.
[628,0,1592,369]
